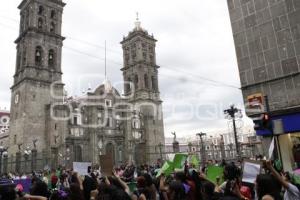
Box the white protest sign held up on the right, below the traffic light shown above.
[242,161,261,183]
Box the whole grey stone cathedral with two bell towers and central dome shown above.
[7,0,164,171]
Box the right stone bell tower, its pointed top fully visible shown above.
[121,16,164,163]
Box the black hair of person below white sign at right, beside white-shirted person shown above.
[256,174,281,200]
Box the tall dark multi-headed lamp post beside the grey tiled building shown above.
[224,105,242,160]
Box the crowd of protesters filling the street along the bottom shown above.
[0,161,300,200]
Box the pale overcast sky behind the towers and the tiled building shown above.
[0,0,251,136]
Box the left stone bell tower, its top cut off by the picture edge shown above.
[9,0,65,153]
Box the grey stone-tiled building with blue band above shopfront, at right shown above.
[228,0,300,170]
